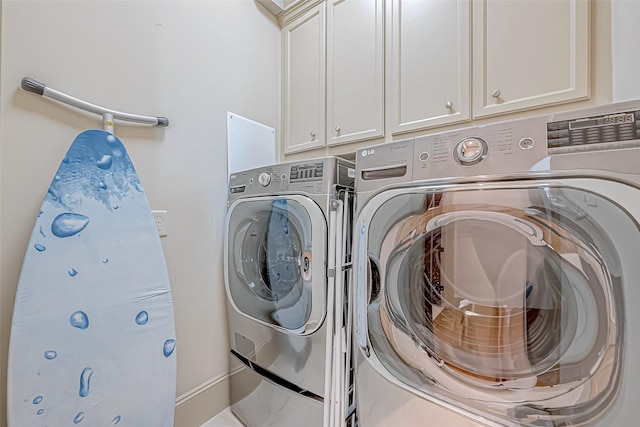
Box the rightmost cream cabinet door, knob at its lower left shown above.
[473,0,589,117]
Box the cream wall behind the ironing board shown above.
[0,0,280,427]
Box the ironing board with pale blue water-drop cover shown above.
[7,130,176,427]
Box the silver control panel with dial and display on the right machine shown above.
[356,100,640,207]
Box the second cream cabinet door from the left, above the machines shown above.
[327,0,384,144]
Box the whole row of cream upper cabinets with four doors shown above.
[278,0,591,154]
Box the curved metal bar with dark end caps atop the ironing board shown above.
[21,77,169,134]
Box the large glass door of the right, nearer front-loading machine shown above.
[356,179,640,425]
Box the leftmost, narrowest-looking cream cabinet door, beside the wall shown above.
[282,3,325,154]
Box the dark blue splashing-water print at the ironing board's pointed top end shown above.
[46,130,142,211]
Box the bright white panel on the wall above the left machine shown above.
[227,111,277,177]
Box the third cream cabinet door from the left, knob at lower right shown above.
[389,0,471,134]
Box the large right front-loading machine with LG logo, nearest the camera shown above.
[353,101,640,427]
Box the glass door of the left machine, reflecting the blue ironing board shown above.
[225,195,327,334]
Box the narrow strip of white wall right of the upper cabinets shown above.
[611,0,640,102]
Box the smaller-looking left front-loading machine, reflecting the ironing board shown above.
[224,157,355,427]
